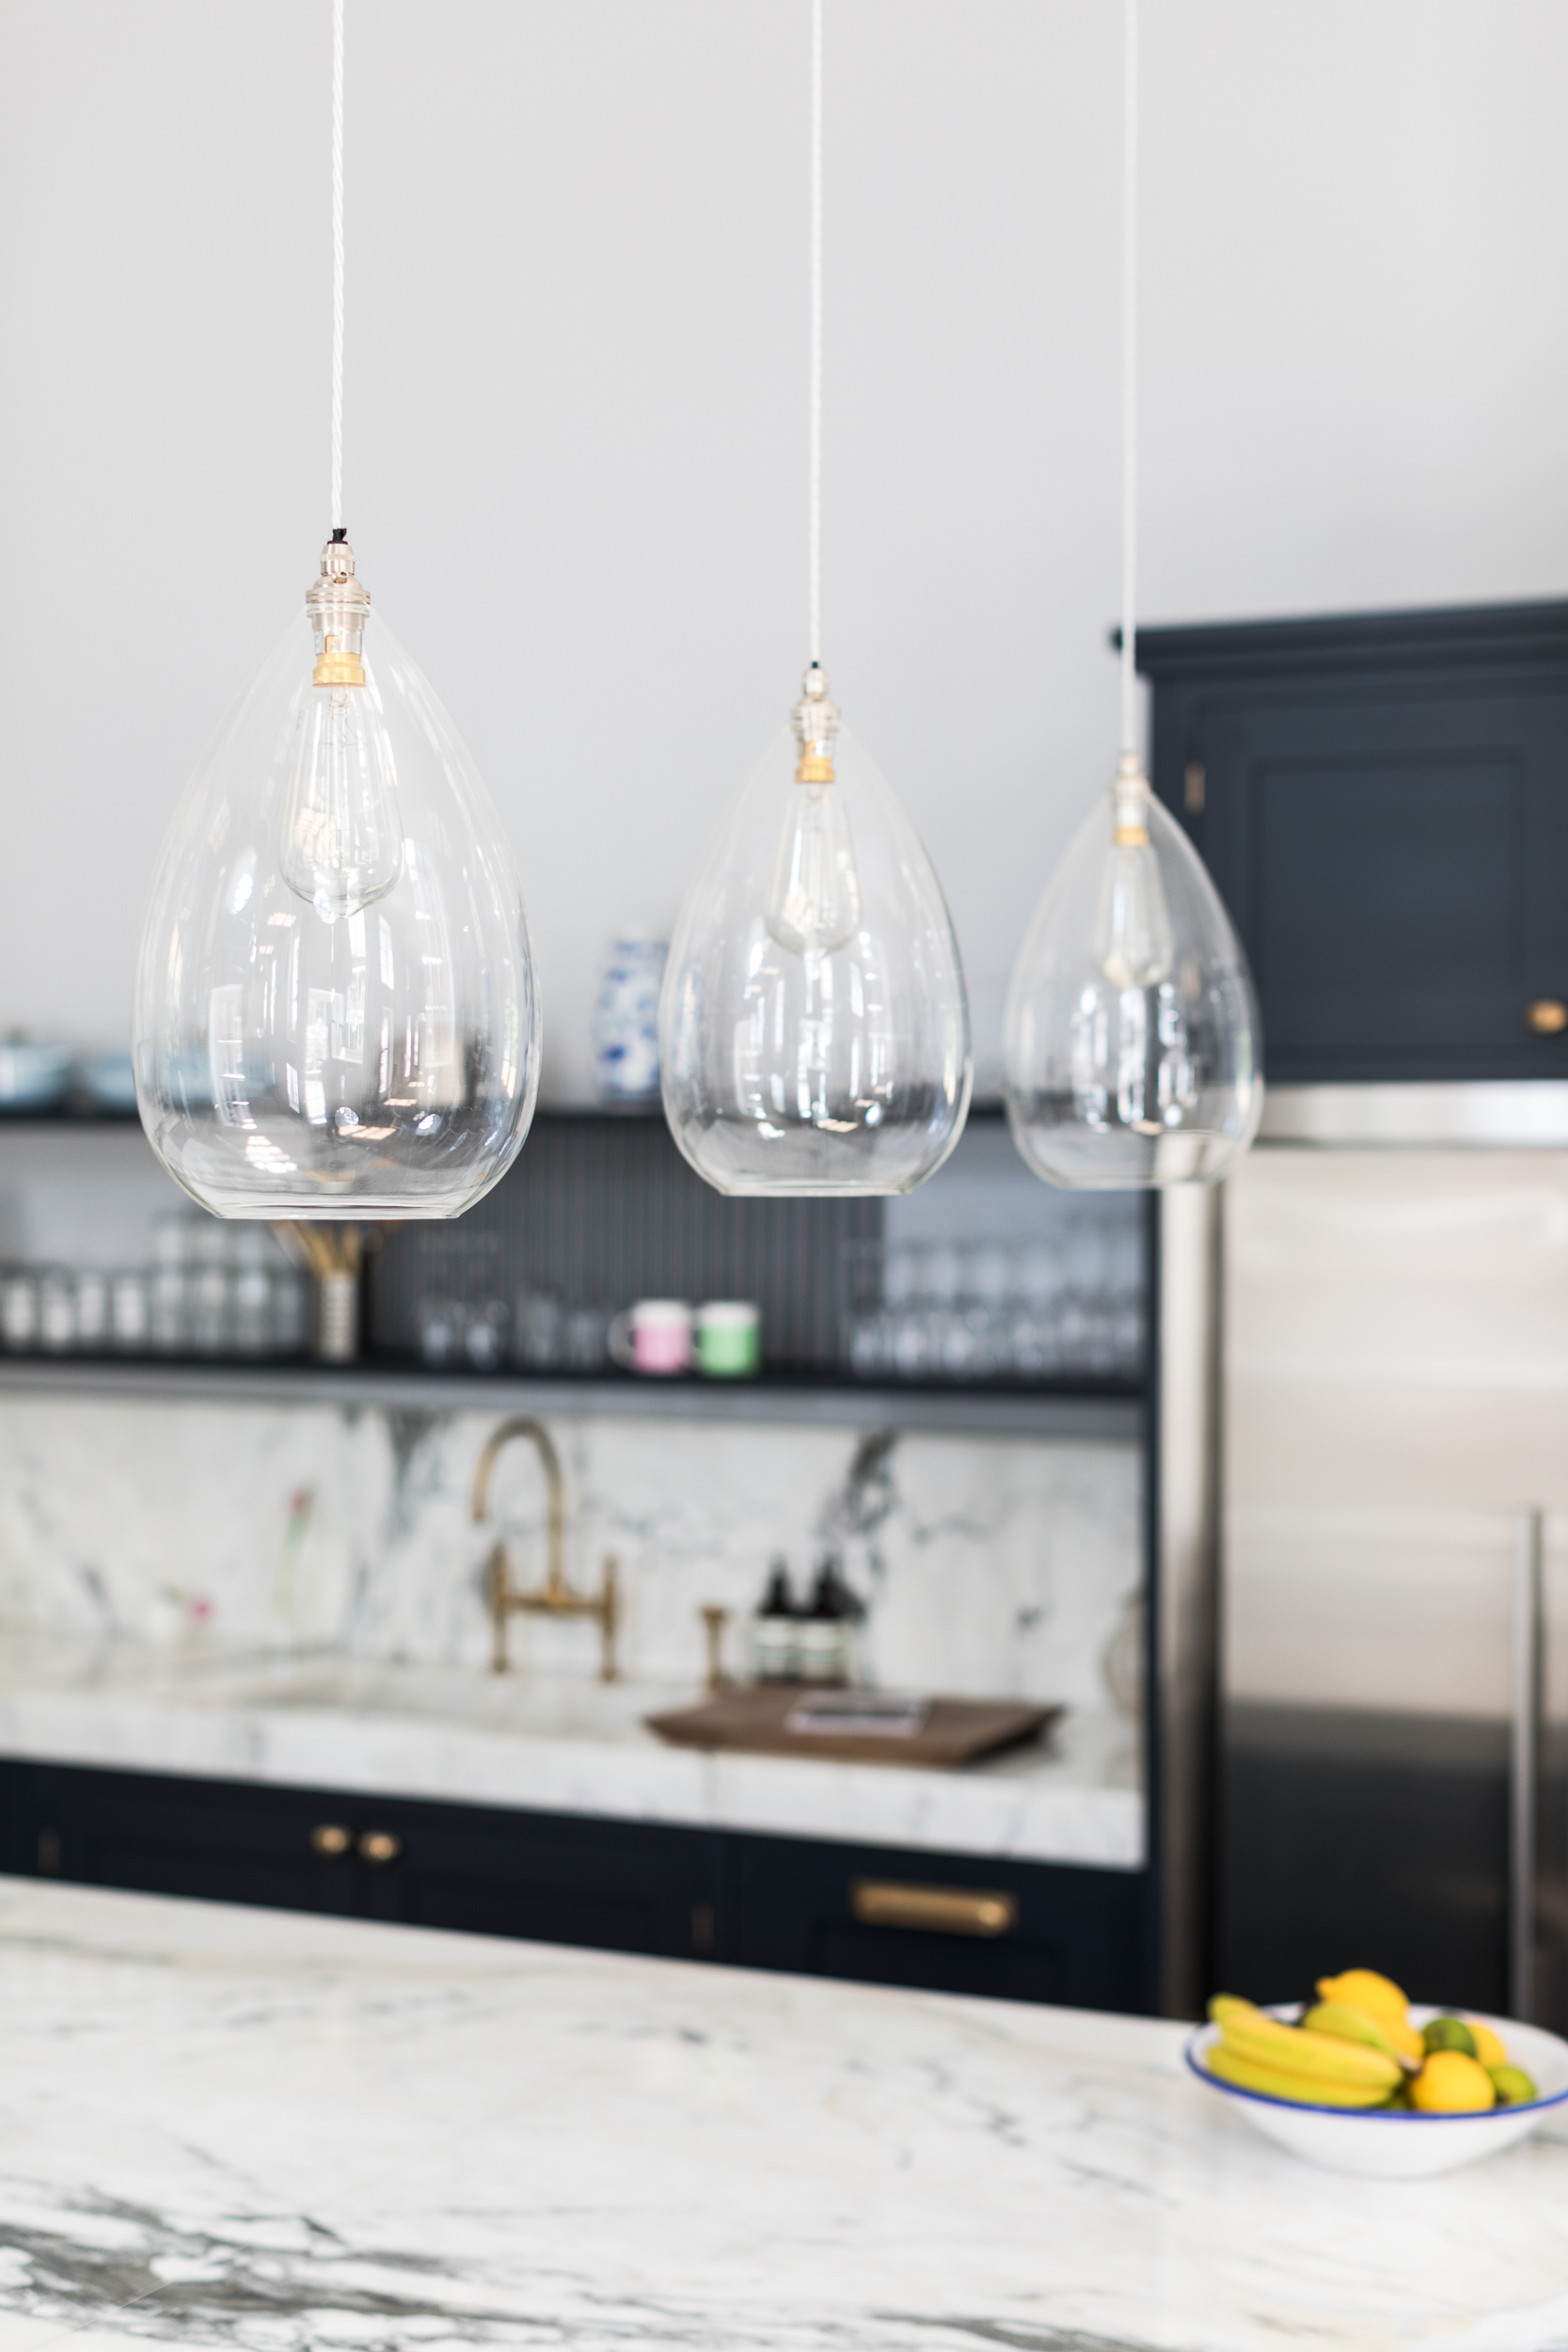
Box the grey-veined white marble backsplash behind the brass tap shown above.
[0,1397,1143,1710]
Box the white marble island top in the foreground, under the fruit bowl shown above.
[0,1880,1568,2352]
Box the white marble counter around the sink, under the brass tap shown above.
[0,1632,1145,1870]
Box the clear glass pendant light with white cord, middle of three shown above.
[658,0,971,1195]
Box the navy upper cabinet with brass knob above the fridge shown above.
[1138,605,1568,1085]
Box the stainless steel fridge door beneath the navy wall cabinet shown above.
[1218,1146,1568,2021]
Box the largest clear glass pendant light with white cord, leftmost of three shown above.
[134,13,538,1221]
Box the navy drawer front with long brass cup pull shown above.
[731,1837,1148,2011]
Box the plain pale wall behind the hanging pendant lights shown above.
[0,0,1568,1096]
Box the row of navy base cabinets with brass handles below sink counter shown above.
[0,1759,1157,2009]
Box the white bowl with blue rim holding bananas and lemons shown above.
[1187,2004,1568,2181]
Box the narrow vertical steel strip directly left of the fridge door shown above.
[1149,1185,1220,2018]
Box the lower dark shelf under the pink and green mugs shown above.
[0,1355,1145,1444]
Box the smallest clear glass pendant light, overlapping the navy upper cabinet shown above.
[1004,0,1262,1188]
